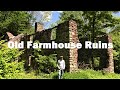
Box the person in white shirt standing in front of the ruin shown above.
[57,56,65,79]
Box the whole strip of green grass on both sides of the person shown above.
[1,69,120,79]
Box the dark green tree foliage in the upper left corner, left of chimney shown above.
[0,11,33,35]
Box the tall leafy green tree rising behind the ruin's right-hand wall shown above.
[83,11,119,67]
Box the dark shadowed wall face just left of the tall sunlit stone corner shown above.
[55,21,70,71]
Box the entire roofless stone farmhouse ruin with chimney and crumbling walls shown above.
[7,20,114,72]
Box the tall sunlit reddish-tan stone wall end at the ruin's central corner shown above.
[69,20,79,72]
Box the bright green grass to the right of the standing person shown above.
[60,69,120,79]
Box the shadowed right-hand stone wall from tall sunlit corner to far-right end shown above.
[78,34,114,73]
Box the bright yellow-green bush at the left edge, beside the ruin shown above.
[0,41,24,77]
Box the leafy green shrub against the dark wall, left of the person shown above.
[33,41,57,73]
